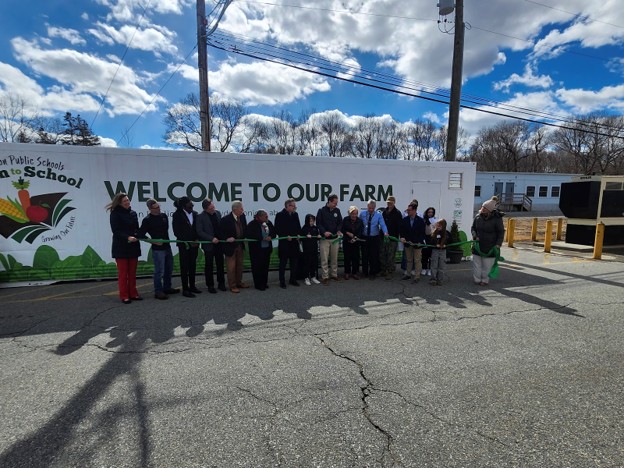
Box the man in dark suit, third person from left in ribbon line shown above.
[171,197,201,297]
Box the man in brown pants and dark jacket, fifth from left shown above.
[221,200,249,294]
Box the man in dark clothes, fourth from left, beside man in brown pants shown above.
[197,198,227,294]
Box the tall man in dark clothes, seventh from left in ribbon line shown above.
[275,198,301,289]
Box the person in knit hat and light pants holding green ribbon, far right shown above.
[471,197,505,286]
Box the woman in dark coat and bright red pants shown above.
[106,193,142,304]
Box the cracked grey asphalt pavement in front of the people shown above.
[0,245,624,468]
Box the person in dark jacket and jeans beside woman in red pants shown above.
[139,198,180,299]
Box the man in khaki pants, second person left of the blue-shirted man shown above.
[316,194,342,286]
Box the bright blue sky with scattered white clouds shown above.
[0,0,624,148]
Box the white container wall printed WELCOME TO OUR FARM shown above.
[0,143,476,283]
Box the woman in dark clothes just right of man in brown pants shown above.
[245,210,276,291]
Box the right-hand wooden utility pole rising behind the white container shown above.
[444,0,465,161]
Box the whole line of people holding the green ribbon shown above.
[107,193,505,304]
